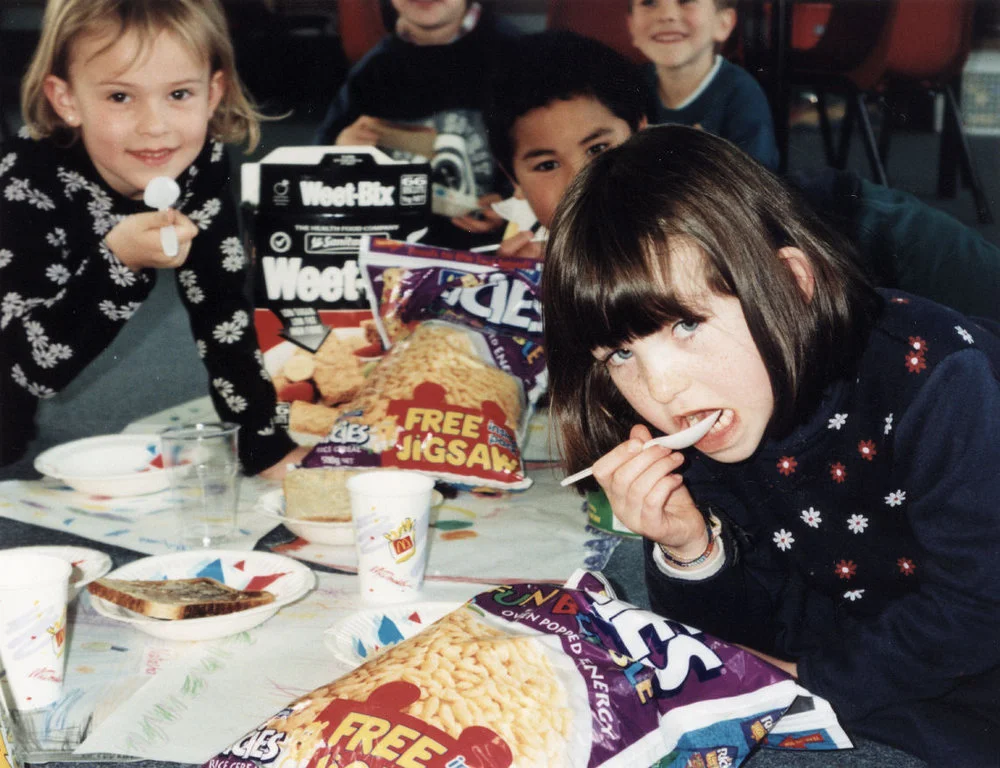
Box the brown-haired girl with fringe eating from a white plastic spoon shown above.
[542,126,1000,766]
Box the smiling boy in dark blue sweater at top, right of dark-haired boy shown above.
[628,0,779,171]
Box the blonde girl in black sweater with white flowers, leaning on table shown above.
[0,0,305,477]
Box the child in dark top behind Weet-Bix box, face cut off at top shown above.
[315,0,518,246]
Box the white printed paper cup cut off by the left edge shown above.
[0,551,73,711]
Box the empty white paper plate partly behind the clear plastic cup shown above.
[35,434,167,496]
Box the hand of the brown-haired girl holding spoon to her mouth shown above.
[594,424,708,560]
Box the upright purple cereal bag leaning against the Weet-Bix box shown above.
[290,238,546,490]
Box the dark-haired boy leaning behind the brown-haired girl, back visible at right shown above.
[488,32,1000,321]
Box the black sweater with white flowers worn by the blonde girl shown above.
[0,133,294,474]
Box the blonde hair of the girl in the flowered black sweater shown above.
[21,0,263,152]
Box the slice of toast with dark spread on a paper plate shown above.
[87,578,274,619]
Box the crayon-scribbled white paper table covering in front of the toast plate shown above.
[5,573,483,764]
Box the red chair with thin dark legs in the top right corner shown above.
[790,0,993,223]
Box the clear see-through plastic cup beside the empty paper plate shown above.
[160,422,240,549]
